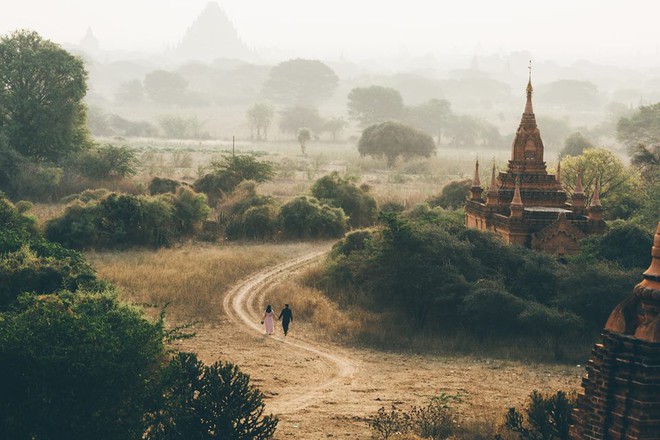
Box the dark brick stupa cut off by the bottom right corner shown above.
[571,223,660,440]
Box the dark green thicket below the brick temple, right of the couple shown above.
[320,209,650,358]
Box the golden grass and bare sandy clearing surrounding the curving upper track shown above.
[88,243,582,439]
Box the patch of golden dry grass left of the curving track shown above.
[86,243,320,322]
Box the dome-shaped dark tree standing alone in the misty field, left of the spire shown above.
[358,121,436,168]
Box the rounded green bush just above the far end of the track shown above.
[279,196,347,238]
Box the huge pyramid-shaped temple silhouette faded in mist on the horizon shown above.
[174,2,255,62]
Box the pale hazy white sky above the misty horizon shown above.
[0,0,660,66]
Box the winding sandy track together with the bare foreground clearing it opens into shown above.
[175,245,583,440]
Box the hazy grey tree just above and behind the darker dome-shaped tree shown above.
[348,86,404,127]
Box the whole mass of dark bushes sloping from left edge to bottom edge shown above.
[0,197,277,440]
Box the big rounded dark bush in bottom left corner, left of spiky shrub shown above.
[0,291,164,439]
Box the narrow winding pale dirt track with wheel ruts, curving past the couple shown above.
[222,250,357,414]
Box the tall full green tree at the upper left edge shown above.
[0,30,90,161]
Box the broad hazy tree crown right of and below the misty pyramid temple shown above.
[262,58,339,106]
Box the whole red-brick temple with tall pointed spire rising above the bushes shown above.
[465,78,607,255]
